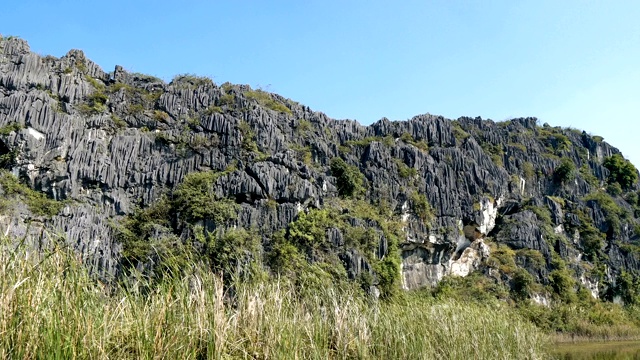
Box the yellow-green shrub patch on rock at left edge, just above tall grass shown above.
[0,170,64,217]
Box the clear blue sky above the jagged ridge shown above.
[5,0,640,167]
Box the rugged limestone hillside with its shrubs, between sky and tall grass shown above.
[0,34,640,304]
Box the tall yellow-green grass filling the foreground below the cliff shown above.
[0,242,547,359]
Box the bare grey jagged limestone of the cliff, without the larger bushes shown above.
[0,38,640,289]
